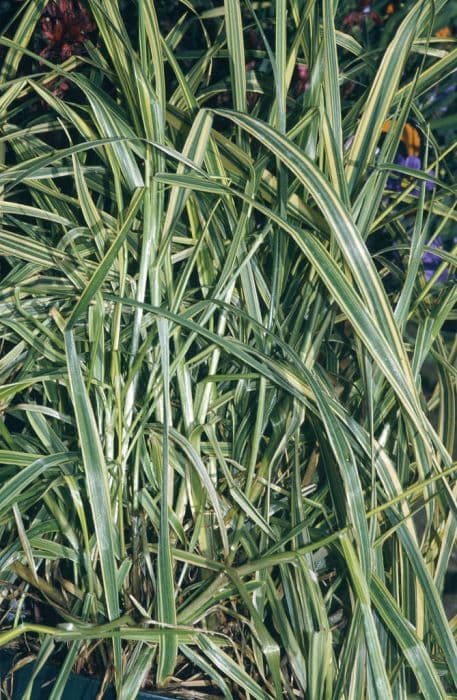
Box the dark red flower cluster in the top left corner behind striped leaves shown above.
[40,0,96,61]
